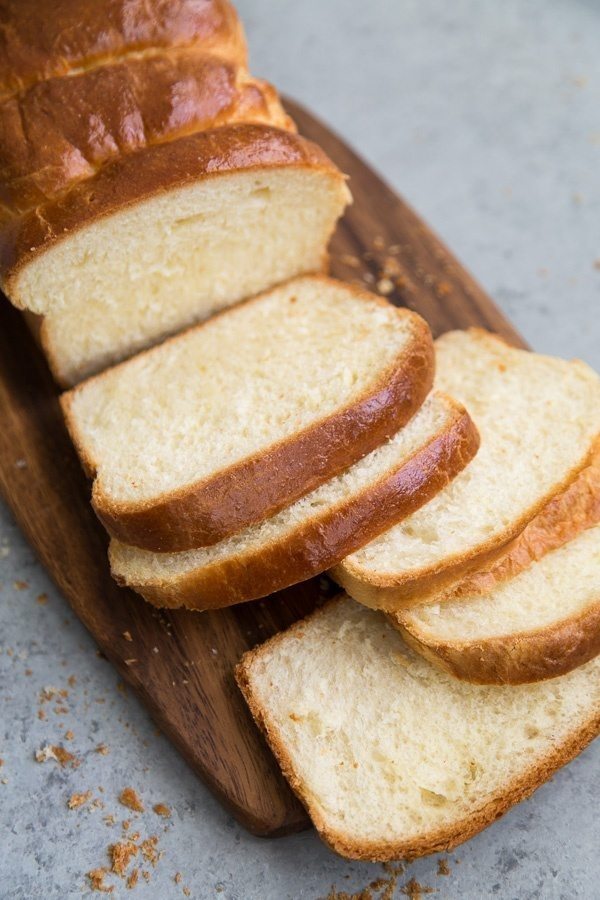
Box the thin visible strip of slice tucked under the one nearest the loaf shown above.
[110,394,479,609]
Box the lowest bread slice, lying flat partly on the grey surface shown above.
[236,598,600,860]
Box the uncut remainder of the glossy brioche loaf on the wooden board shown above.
[0,0,349,385]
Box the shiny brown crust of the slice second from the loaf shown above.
[111,404,479,610]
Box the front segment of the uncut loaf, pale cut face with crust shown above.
[3,125,349,385]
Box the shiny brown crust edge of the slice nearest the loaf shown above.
[61,276,435,553]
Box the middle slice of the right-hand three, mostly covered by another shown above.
[390,525,600,684]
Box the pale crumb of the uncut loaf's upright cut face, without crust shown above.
[25,166,349,386]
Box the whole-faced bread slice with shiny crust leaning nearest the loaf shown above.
[62,277,434,552]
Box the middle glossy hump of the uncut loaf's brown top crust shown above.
[0,52,293,217]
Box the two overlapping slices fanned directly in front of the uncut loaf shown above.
[62,276,479,610]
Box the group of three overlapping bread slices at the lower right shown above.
[237,330,600,860]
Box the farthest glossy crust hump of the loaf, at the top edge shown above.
[0,0,246,101]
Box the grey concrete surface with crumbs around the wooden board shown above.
[0,0,600,900]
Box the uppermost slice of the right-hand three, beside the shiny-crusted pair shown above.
[332,330,600,612]
